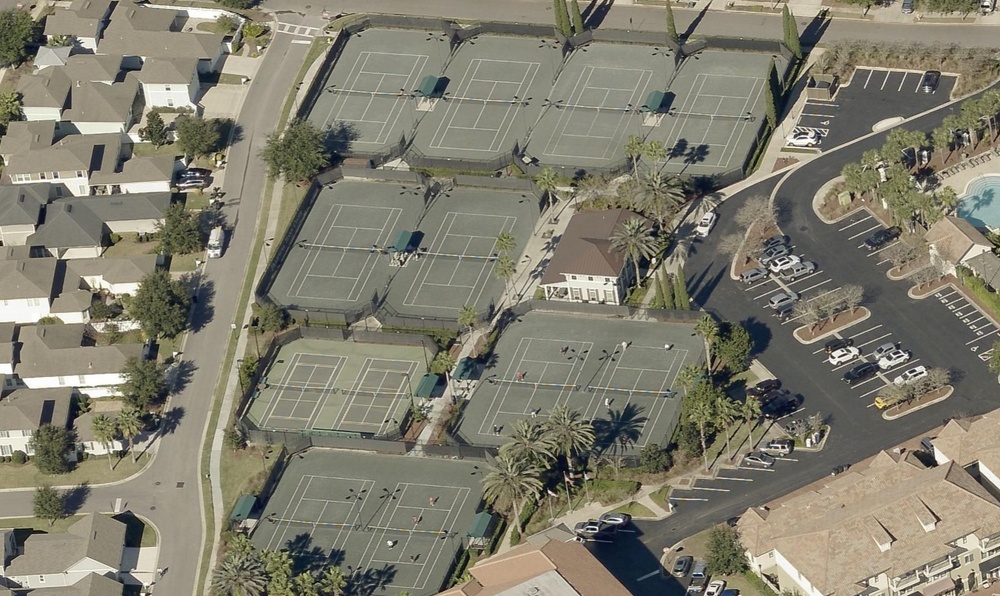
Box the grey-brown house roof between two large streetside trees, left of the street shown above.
[14,323,142,379]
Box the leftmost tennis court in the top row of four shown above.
[309,29,447,151]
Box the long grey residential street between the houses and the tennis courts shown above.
[0,35,309,594]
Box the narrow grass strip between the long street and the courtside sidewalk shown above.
[198,32,329,583]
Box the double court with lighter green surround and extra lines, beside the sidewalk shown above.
[247,338,427,436]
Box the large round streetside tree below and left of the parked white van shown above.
[128,269,191,338]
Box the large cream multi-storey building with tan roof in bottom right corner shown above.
[738,451,1000,596]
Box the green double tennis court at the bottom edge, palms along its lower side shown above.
[252,449,481,596]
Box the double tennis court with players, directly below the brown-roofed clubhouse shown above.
[459,312,704,449]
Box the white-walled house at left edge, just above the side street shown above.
[0,387,73,456]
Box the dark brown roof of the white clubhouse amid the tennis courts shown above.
[541,209,651,284]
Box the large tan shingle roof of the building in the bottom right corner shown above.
[739,452,1000,595]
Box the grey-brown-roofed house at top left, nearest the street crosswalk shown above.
[98,2,225,73]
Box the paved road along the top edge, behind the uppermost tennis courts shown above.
[263,0,996,47]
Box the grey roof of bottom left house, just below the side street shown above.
[6,513,125,576]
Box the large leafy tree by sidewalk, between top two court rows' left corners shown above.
[260,120,330,182]
